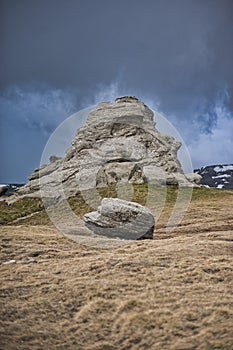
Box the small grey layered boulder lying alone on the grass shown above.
[83,198,155,239]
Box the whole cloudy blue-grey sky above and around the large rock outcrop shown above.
[0,0,233,183]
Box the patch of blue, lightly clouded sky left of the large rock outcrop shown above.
[0,87,78,182]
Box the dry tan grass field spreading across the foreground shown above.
[0,189,233,350]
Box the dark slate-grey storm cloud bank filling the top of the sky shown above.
[0,0,233,109]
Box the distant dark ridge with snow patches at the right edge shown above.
[194,164,233,190]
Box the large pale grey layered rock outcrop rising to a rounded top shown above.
[12,96,200,198]
